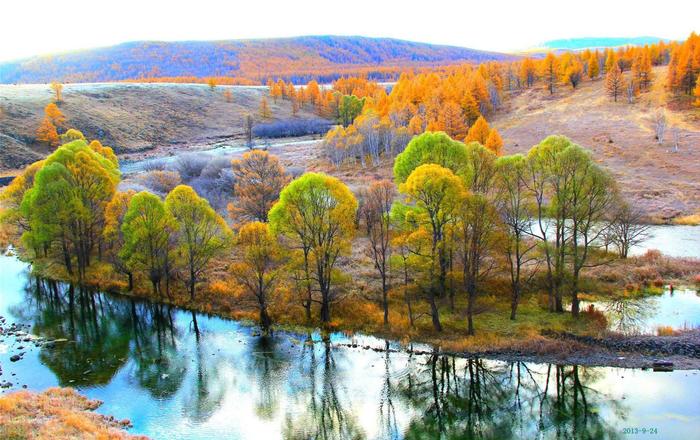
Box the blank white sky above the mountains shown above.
[0,0,700,61]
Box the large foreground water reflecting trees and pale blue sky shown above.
[0,256,700,439]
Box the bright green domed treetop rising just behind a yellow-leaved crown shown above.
[394,132,467,184]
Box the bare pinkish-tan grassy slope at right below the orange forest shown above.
[491,68,700,220]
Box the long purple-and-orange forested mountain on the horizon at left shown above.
[0,36,511,83]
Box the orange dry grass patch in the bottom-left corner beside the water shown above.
[0,388,145,440]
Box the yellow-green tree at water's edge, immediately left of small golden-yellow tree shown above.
[165,185,232,301]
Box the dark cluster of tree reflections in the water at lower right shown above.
[398,355,622,439]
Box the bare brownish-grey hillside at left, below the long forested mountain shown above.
[0,83,317,171]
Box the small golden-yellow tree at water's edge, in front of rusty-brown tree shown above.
[231,222,283,331]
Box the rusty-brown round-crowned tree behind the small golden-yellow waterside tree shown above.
[229,150,290,222]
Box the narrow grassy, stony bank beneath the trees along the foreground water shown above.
[6,251,700,369]
